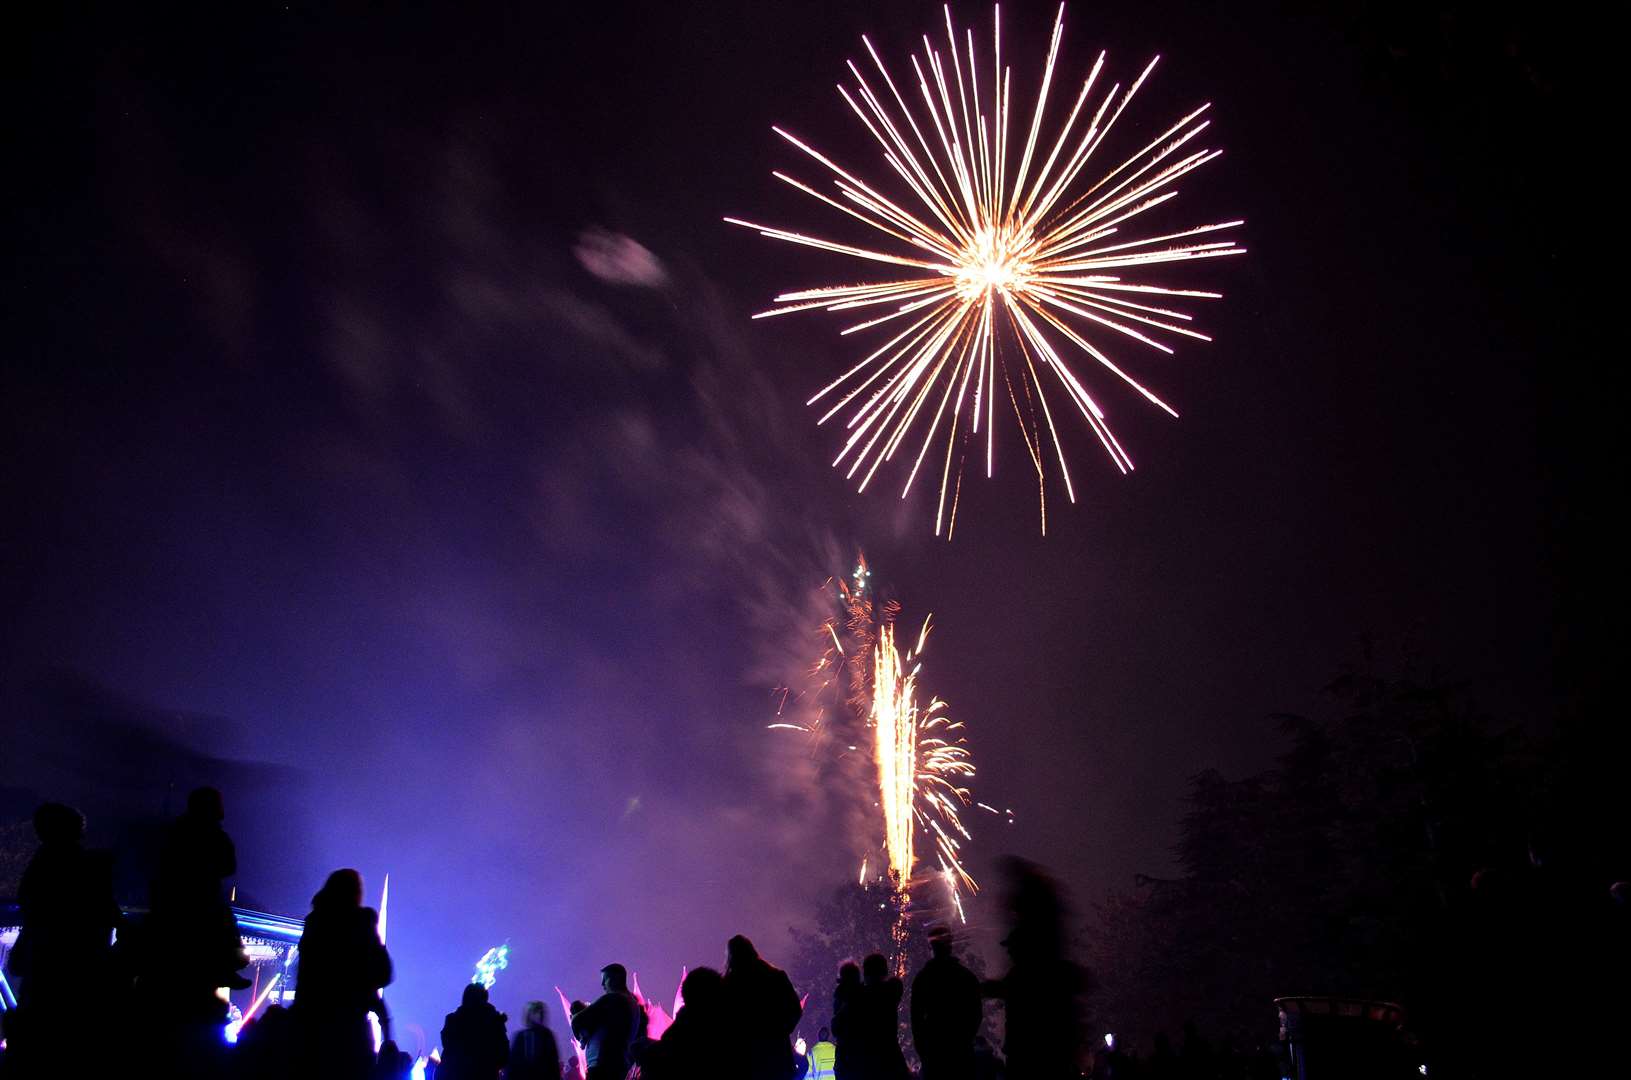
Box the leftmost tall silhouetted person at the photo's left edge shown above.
[7,803,122,1075]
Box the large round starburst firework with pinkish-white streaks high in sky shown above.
[726,5,1244,538]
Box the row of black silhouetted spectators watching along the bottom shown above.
[0,788,1080,1080]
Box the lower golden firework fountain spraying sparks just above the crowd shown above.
[770,556,995,917]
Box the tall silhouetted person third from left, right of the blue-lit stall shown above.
[294,870,391,1077]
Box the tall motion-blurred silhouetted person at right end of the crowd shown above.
[982,858,1086,1080]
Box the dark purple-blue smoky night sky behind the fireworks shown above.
[0,0,1578,1050]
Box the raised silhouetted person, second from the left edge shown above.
[150,788,250,998]
